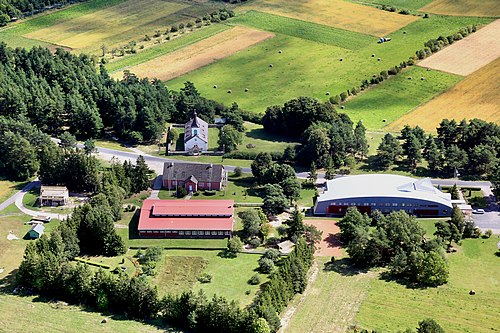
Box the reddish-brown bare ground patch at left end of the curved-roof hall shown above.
[304,220,342,257]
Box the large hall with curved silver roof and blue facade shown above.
[314,174,453,217]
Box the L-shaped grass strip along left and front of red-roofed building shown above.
[116,210,227,249]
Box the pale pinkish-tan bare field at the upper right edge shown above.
[418,20,500,76]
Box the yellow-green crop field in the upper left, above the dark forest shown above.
[25,0,188,50]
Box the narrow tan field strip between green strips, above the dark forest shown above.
[113,26,274,81]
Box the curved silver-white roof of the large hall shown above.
[318,174,452,208]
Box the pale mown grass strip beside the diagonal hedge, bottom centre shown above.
[286,257,376,333]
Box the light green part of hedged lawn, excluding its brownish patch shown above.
[158,250,264,305]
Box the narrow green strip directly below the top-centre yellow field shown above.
[231,10,373,50]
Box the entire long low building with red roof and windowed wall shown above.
[137,199,234,238]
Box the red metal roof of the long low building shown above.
[138,199,234,230]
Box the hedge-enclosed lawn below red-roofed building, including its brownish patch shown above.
[153,250,265,305]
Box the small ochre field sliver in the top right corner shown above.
[419,0,500,17]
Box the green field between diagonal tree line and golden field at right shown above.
[343,66,462,129]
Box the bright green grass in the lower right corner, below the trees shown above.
[356,237,500,333]
